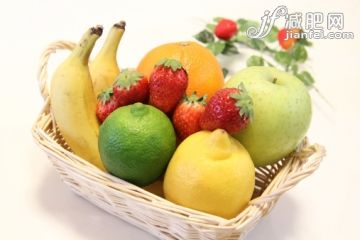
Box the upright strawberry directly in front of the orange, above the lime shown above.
[149,59,188,113]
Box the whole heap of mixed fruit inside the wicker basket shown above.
[50,21,311,218]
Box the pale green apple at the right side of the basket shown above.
[225,67,311,166]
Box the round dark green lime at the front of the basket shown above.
[99,103,176,186]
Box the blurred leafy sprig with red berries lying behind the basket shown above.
[194,17,315,87]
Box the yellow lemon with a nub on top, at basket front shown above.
[164,129,255,219]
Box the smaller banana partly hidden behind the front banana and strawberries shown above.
[90,21,125,96]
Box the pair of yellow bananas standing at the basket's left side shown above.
[50,22,125,170]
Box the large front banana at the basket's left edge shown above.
[50,26,105,170]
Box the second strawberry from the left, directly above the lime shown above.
[113,69,149,107]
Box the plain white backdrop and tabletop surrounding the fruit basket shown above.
[0,0,360,240]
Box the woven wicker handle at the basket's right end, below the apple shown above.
[250,144,326,209]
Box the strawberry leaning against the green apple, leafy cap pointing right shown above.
[200,84,253,134]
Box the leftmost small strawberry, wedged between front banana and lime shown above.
[96,87,119,122]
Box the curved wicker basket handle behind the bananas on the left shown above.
[37,41,76,101]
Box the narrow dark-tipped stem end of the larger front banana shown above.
[72,25,103,64]
